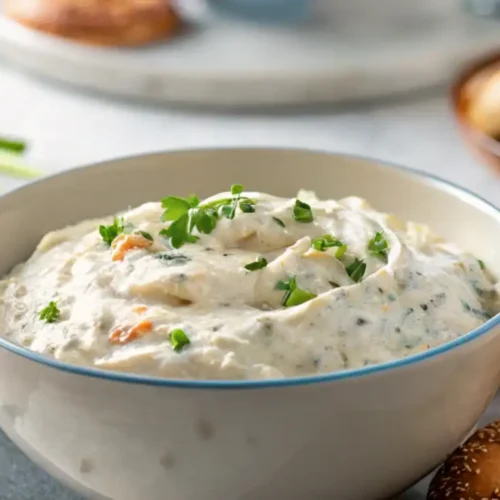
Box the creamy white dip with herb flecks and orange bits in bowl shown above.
[0,189,500,379]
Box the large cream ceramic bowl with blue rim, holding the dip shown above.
[0,150,500,500]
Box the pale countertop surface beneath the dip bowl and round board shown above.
[0,66,500,500]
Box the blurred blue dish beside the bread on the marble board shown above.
[207,0,312,23]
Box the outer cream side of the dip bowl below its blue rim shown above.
[0,322,500,500]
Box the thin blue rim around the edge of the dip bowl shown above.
[0,146,500,390]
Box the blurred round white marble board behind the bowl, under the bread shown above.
[0,0,500,107]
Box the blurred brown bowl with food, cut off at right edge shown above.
[451,51,500,173]
